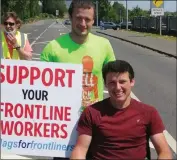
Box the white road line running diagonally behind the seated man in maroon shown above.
[103,91,177,153]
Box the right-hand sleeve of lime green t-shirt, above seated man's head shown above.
[104,40,115,64]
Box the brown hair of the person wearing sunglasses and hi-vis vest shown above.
[3,12,22,29]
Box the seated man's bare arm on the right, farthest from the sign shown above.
[150,133,172,159]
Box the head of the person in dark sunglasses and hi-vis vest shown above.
[3,12,22,32]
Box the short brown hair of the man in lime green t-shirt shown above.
[68,0,95,17]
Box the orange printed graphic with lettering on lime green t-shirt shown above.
[82,56,98,108]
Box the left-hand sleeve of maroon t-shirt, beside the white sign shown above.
[77,107,93,136]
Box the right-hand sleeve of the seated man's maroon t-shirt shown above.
[149,108,165,136]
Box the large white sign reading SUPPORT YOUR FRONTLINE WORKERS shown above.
[0,59,82,157]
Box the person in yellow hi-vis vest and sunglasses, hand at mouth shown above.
[0,12,33,60]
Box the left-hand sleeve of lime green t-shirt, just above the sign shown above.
[40,42,54,62]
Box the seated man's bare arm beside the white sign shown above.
[70,134,92,160]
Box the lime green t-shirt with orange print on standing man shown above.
[40,33,115,107]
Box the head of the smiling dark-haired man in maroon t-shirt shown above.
[102,60,135,105]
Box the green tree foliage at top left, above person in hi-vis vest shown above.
[1,0,66,20]
